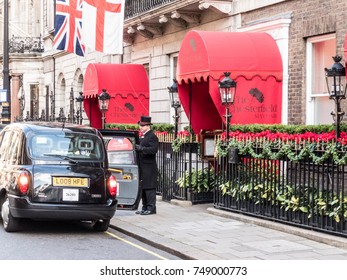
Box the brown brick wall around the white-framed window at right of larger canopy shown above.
[242,0,347,124]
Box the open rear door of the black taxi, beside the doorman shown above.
[99,129,141,210]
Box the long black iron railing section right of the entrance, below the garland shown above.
[214,150,347,236]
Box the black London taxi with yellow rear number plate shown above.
[0,122,118,232]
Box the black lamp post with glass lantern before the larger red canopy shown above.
[218,72,236,141]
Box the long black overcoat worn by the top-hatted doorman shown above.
[139,130,159,189]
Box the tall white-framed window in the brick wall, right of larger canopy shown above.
[306,34,336,124]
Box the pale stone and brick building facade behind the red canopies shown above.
[0,0,347,129]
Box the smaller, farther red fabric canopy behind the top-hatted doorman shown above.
[83,63,149,128]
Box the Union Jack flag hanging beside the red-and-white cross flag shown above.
[54,0,85,56]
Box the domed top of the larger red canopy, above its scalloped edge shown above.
[177,31,283,84]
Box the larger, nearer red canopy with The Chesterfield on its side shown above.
[177,31,283,133]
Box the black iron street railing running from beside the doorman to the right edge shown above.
[157,135,347,237]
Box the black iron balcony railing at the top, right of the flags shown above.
[124,0,177,19]
